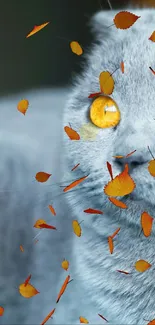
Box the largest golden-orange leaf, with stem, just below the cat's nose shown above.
[104,164,136,196]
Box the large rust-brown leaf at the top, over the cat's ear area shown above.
[113,11,140,29]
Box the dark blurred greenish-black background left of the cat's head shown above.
[0,0,152,95]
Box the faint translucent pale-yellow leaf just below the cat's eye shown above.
[79,123,99,141]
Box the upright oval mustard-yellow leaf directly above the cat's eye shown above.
[99,71,114,95]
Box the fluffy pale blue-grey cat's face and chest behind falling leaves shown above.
[64,9,155,324]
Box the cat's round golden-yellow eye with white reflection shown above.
[90,96,121,128]
